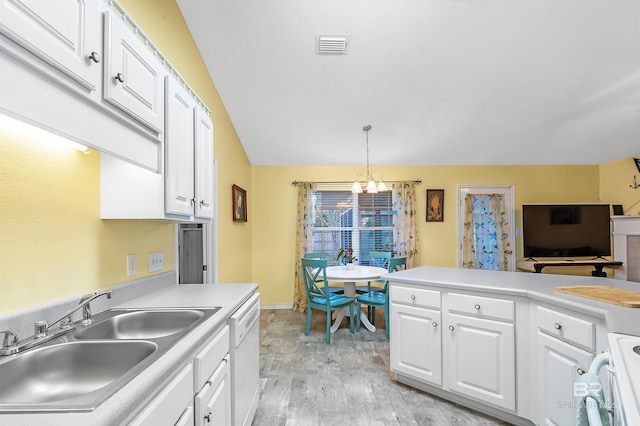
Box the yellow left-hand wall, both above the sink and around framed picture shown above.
[0,0,253,313]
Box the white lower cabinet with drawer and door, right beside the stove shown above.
[535,306,595,426]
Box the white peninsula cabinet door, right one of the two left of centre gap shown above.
[444,313,516,410]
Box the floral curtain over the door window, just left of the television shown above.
[462,194,509,271]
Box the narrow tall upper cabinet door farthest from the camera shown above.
[195,108,214,219]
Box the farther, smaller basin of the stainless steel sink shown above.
[75,309,204,339]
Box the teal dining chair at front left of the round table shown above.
[302,258,355,343]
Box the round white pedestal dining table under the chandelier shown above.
[326,265,389,333]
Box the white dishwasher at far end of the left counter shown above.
[229,293,260,426]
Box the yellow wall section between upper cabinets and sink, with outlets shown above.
[0,128,174,312]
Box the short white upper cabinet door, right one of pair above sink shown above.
[104,12,167,134]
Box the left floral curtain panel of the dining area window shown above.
[293,182,317,312]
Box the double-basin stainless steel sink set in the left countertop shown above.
[0,308,220,413]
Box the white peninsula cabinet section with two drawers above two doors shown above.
[390,283,516,413]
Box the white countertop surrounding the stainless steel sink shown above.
[0,284,258,426]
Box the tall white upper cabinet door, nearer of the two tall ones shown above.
[164,77,195,215]
